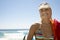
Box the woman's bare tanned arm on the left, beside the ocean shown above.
[27,23,40,40]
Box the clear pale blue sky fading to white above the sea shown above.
[0,0,60,29]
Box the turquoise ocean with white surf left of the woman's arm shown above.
[0,29,29,40]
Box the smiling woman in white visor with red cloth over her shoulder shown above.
[27,3,60,40]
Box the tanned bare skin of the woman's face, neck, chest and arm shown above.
[27,5,52,40]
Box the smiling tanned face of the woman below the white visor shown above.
[39,8,52,19]
